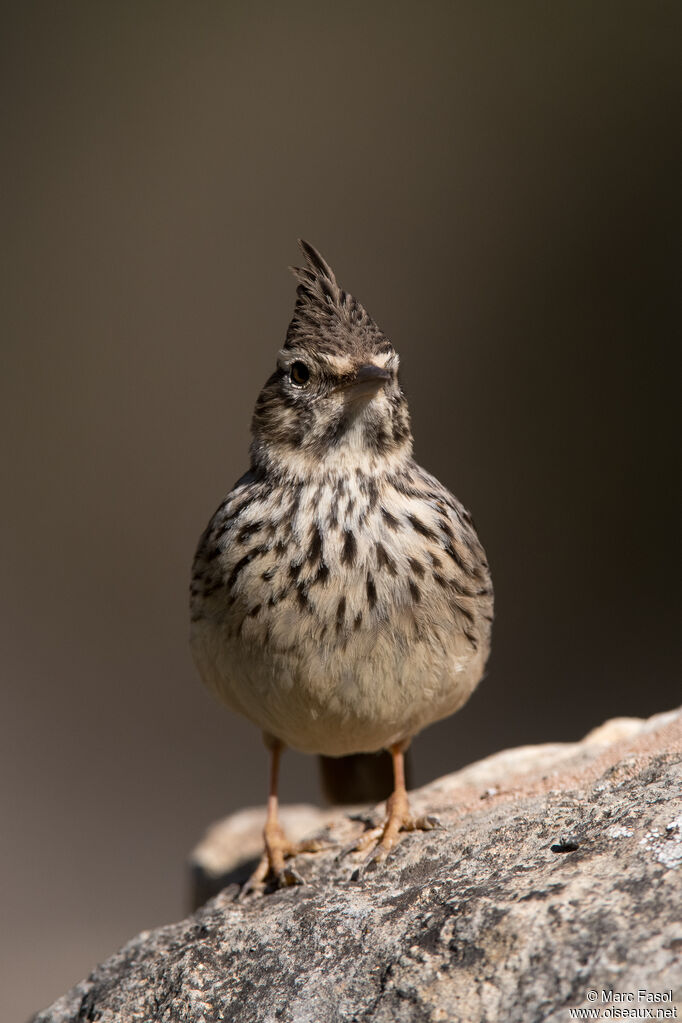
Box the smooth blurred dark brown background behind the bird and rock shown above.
[0,0,682,1019]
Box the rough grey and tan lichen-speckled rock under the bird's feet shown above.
[35,710,682,1023]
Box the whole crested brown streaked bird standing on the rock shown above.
[190,240,493,890]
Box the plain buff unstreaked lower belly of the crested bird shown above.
[192,609,488,756]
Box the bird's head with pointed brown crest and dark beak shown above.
[252,241,412,478]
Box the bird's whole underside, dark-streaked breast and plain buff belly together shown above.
[192,464,492,756]
